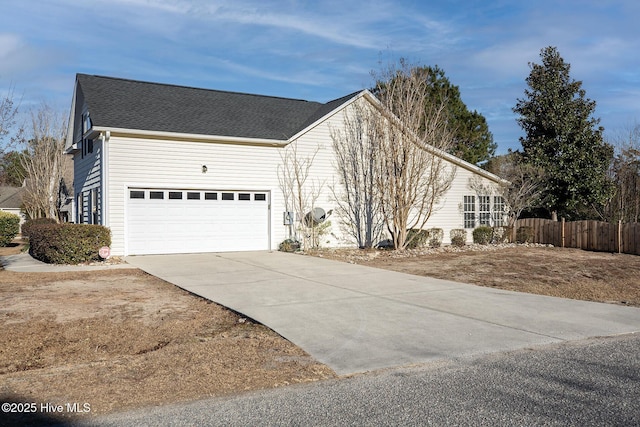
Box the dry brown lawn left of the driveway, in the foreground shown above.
[0,244,335,424]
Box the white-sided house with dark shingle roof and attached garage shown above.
[67,74,504,255]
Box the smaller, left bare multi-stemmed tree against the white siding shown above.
[331,101,384,248]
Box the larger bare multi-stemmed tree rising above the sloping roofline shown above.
[376,61,456,250]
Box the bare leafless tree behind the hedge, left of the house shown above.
[23,103,67,219]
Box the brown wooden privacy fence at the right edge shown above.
[512,218,640,255]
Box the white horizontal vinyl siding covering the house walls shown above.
[91,96,510,255]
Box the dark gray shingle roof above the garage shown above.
[77,74,358,140]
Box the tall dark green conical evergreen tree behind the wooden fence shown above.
[513,46,613,219]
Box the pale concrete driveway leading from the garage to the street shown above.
[126,252,640,375]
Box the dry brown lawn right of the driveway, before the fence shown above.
[315,245,640,306]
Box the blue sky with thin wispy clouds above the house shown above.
[0,0,640,153]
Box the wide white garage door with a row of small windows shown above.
[126,188,270,255]
